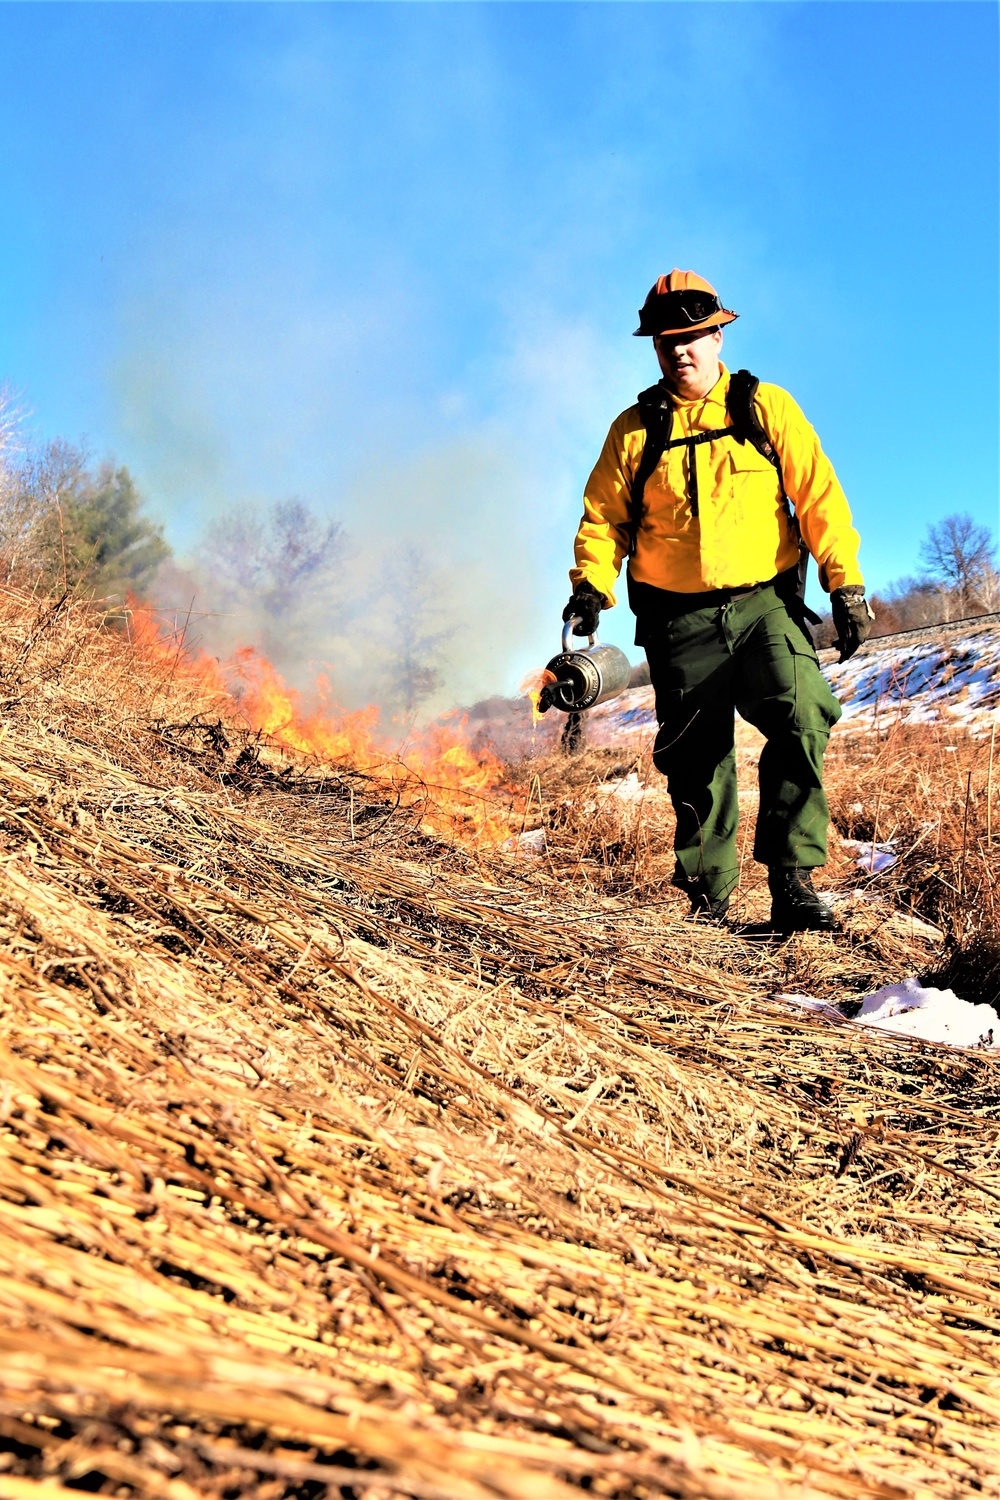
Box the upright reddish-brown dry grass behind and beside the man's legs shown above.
[511,707,1000,942]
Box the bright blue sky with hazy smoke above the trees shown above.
[0,0,1000,693]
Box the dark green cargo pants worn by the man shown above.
[642,587,841,900]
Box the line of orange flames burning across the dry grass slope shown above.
[129,600,520,846]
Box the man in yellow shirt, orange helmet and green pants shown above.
[562,270,873,932]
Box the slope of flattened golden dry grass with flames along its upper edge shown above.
[0,591,1000,1500]
